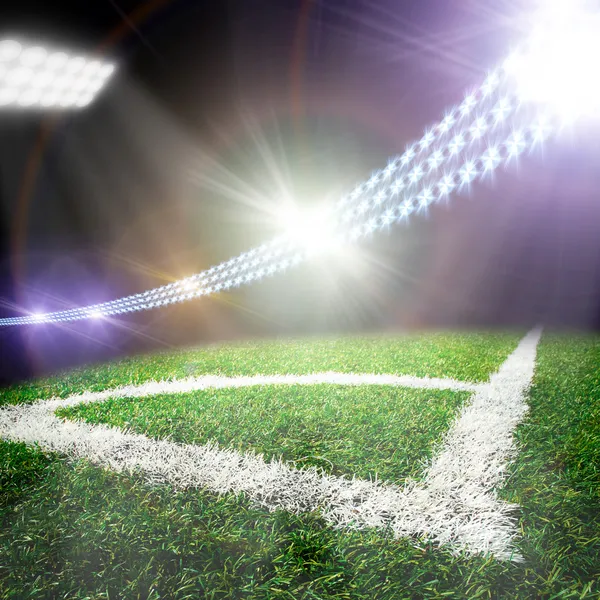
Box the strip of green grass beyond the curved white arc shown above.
[0,332,523,405]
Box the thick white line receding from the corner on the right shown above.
[408,329,542,560]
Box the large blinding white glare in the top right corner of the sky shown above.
[504,0,600,121]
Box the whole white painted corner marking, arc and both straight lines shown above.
[0,330,541,560]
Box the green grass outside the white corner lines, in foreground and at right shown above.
[0,334,600,600]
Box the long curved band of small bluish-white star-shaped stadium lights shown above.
[0,61,559,326]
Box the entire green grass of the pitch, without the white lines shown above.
[0,332,600,600]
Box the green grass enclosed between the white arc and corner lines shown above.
[57,385,469,483]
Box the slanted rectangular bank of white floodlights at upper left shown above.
[0,39,115,110]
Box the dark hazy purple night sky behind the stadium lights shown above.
[0,0,600,381]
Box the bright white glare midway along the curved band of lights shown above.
[279,206,339,254]
